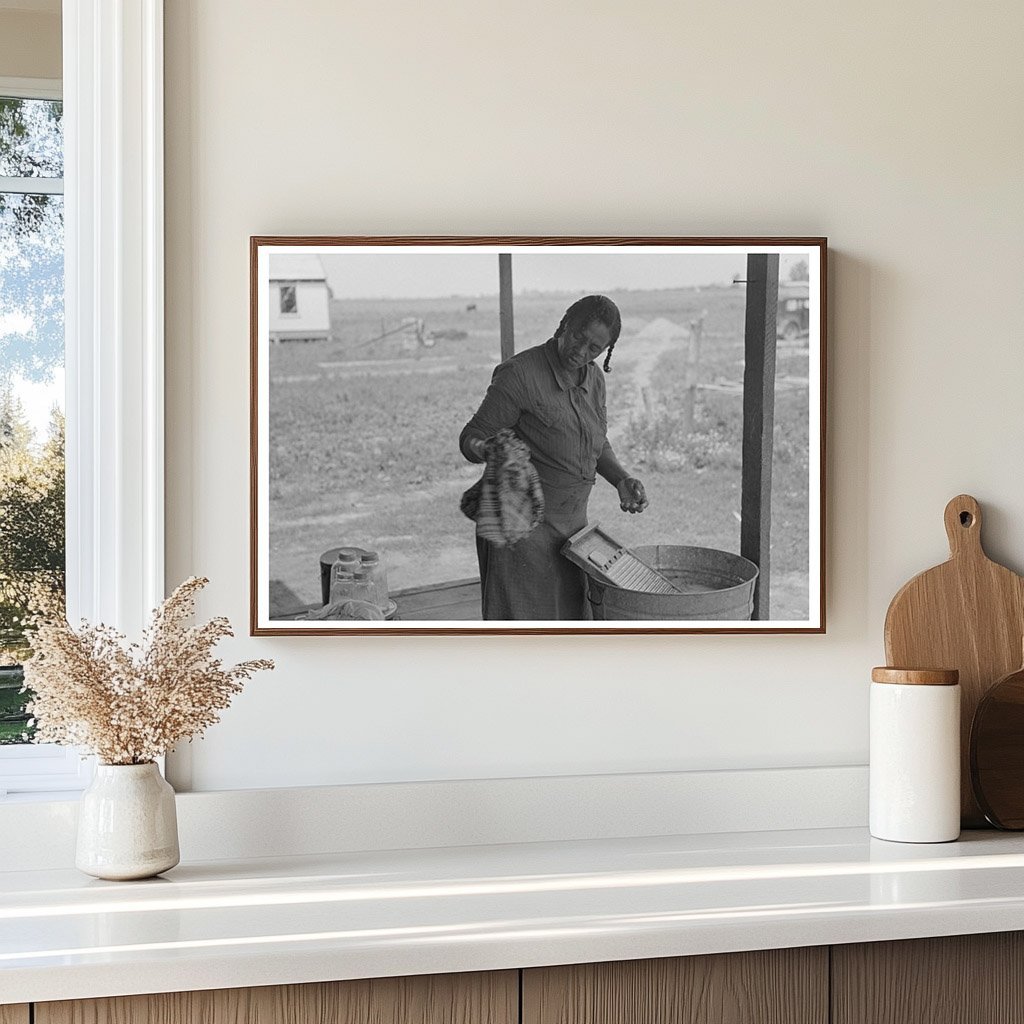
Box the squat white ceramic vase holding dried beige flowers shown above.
[75,761,181,882]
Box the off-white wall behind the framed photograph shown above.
[161,0,1024,790]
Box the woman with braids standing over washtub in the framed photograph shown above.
[459,295,647,621]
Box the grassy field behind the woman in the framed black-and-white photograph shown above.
[269,288,808,618]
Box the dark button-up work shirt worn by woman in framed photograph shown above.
[459,338,609,487]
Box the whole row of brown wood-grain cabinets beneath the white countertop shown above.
[16,932,1024,1024]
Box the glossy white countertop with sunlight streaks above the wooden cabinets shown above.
[0,828,1024,1004]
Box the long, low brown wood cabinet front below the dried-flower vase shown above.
[35,971,519,1024]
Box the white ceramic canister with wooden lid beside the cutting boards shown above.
[870,669,961,843]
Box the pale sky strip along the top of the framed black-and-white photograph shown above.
[299,253,770,299]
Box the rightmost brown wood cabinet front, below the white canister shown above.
[831,932,1024,1024]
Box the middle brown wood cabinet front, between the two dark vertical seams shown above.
[522,947,827,1024]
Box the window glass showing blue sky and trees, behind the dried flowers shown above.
[0,82,65,745]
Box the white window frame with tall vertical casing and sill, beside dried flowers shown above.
[0,0,164,800]
